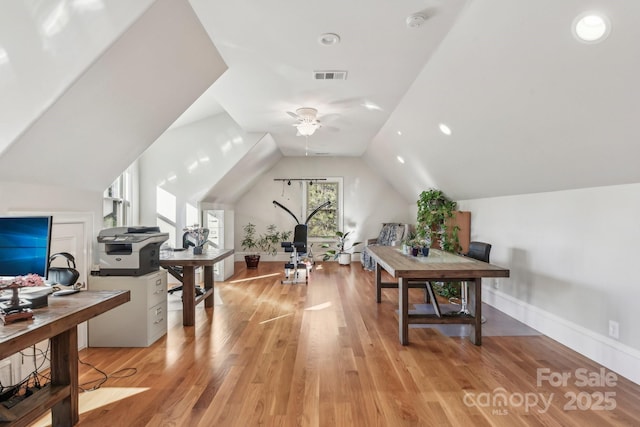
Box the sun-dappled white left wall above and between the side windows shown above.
[139,113,263,244]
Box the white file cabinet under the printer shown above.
[89,270,167,347]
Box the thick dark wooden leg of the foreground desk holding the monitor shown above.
[51,326,79,426]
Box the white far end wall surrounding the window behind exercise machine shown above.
[235,157,415,260]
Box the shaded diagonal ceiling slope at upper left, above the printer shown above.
[0,0,227,191]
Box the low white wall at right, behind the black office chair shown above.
[459,184,640,382]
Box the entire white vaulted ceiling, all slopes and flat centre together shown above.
[0,0,640,201]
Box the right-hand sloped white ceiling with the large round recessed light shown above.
[365,0,640,200]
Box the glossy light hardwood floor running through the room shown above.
[36,262,640,427]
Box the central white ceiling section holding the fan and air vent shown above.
[191,0,465,157]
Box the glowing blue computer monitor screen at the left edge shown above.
[0,216,51,279]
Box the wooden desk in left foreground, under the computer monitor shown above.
[0,291,129,426]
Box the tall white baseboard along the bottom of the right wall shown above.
[482,285,640,384]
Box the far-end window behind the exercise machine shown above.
[303,178,342,239]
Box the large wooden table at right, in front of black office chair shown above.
[366,246,509,345]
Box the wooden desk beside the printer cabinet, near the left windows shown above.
[160,248,233,326]
